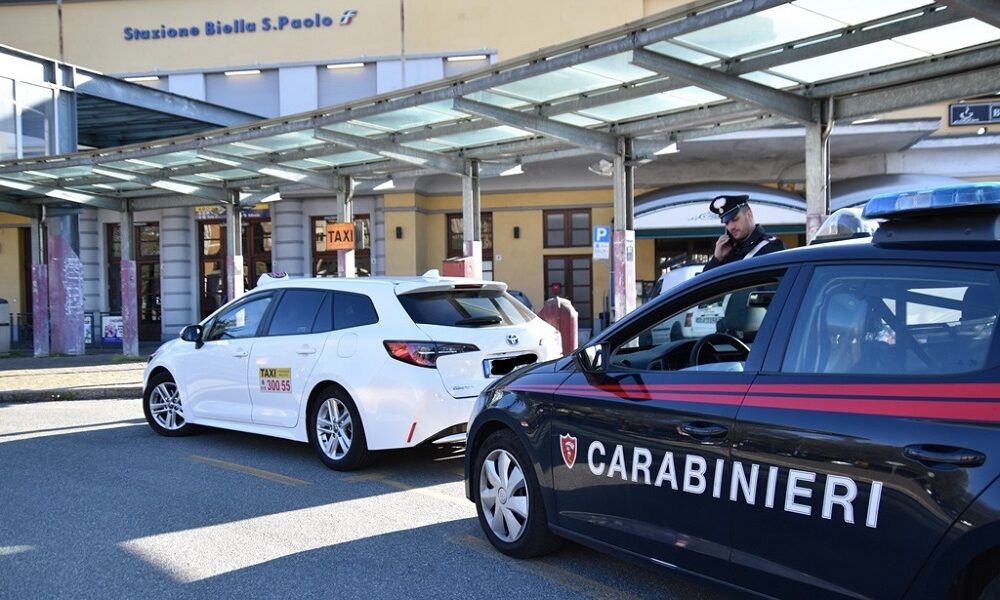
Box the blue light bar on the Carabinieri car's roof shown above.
[862,182,1000,219]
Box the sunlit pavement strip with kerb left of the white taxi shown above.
[0,342,160,403]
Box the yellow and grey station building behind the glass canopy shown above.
[0,0,1000,350]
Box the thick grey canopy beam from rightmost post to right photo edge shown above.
[834,66,1000,119]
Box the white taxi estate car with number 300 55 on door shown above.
[143,271,561,470]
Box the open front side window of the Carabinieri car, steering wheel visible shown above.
[610,280,778,372]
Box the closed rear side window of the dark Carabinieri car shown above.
[782,265,1000,375]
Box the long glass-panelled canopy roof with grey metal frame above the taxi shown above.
[0,0,1000,210]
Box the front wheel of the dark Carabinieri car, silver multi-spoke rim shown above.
[474,430,560,558]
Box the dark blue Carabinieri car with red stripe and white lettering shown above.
[466,183,1000,599]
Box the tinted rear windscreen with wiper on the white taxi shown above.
[399,290,535,327]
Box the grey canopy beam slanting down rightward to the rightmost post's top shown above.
[632,48,816,123]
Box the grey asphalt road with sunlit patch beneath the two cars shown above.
[0,400,729,600]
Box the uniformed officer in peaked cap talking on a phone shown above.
[704,195,785,271]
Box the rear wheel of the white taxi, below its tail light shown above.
[309,387,375,471]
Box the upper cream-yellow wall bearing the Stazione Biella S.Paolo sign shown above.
[0,0,672,73]
